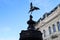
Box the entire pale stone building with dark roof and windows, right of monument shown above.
[35,5,60,40]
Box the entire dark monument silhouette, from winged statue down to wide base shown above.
[19,2,43,40]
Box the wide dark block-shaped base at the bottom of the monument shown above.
[20,30,42,40]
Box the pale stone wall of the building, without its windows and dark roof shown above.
[35,6,60,40]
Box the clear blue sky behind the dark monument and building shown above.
[0,0,60,40]
